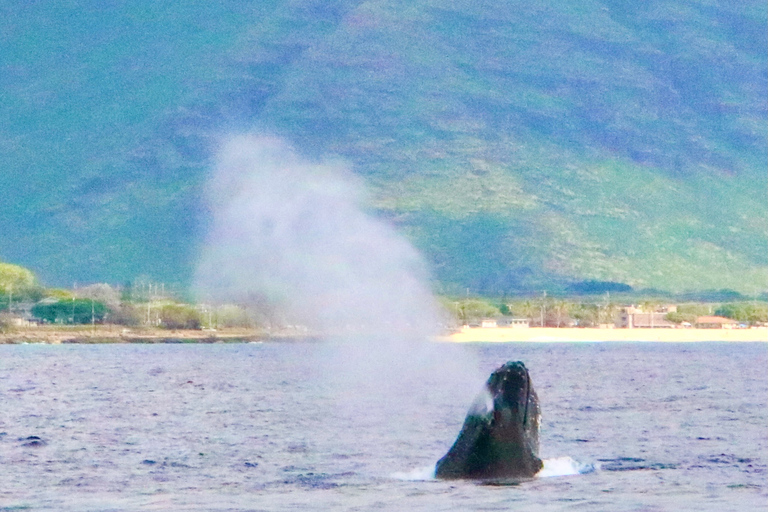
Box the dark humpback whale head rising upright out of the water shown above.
[435,361,542,482]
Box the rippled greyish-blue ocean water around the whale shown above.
[0,342,768,512]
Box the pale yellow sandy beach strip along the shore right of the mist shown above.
[441,327,768,343]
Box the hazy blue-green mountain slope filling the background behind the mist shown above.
[0,0,768,294]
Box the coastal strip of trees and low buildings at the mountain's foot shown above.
[0,262,768,343]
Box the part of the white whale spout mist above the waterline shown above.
[197,135,438,340]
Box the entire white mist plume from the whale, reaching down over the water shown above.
[197,135,482,456]
